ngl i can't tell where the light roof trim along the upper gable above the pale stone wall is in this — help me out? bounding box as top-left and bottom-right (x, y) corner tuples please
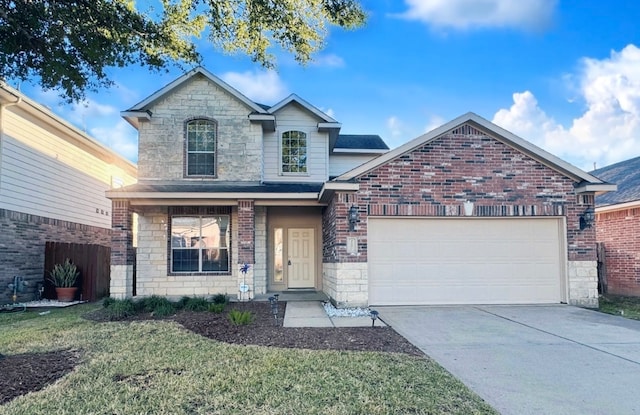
(120, 66), (268, 128)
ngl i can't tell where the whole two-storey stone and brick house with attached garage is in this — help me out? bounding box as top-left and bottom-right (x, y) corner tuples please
(108, 68), (615, 307)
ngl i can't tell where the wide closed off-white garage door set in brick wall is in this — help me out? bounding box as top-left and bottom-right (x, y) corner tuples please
(368, 218), (566, 305)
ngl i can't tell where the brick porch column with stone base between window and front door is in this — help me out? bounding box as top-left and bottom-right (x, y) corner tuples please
(238, 200), (256, 301)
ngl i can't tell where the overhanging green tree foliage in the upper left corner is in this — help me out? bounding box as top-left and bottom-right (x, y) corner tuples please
(0, 0), (365, 100)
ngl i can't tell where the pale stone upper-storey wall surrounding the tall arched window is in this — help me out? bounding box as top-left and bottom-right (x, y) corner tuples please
(138, 75), (262, 182)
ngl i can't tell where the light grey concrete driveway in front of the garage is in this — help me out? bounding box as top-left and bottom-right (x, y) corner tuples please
(375, 305), (640, 415)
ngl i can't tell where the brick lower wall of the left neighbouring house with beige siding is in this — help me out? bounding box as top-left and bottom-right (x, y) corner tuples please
(0, 209), (111, 304)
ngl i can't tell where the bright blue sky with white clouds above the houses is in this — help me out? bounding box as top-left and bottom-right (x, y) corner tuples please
(13, 0), (640, 171)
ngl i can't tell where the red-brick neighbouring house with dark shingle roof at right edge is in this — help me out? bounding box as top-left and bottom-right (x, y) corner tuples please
(591, 157), (640, 296)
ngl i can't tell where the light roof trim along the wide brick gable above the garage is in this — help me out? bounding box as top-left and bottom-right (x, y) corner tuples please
(334, 112), (615, 192)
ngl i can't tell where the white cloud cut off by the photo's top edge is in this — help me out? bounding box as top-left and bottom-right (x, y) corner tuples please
(402, 0), (558, 30)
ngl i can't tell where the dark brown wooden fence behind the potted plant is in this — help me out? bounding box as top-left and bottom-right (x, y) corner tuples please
(44, 242), (111, 301)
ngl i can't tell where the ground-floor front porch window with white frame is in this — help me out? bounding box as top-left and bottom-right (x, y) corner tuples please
(171, 215), (229, 273)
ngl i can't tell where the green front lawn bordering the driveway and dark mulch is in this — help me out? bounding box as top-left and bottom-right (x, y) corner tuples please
(0, 305), (496, 415)
